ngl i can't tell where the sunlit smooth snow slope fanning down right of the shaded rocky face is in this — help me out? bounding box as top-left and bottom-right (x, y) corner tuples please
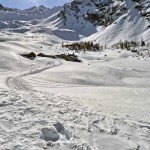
(88, 0), (150, 44)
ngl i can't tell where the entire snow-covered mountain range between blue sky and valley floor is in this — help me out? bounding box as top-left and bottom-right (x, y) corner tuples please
(0, 0), (150, 44)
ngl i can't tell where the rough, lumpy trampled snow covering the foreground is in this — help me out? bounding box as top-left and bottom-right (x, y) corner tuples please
(0, 89), (150, 150)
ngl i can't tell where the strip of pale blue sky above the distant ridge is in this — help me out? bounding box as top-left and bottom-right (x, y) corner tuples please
(0, 0), (70, 9)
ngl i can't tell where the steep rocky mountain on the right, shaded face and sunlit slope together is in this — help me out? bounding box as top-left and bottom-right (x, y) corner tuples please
(60, 0), (150, 43)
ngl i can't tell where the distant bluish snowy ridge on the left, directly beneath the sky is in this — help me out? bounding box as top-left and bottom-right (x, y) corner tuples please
(0, 6), (61, 33)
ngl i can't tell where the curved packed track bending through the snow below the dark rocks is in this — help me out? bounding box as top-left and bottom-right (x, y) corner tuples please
(5, 61), (62, 91)
